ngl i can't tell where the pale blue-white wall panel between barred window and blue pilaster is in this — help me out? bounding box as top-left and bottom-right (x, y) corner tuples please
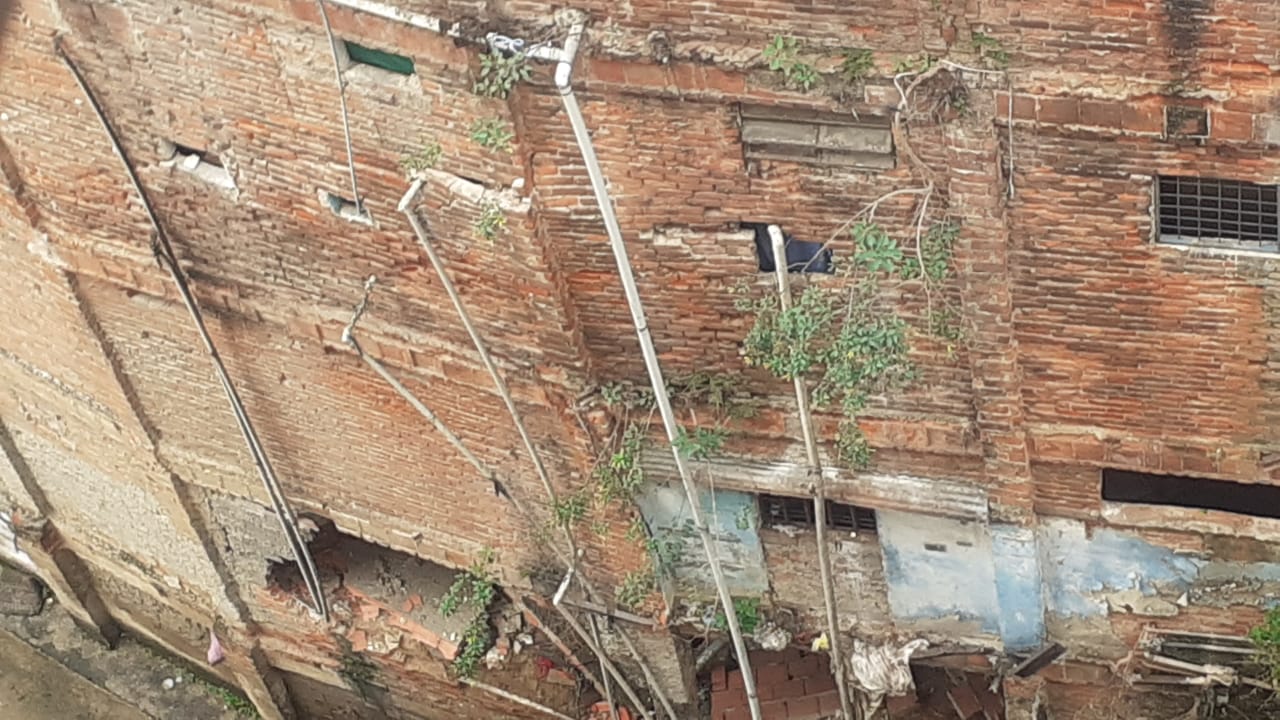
(877, 510), (1001, 637)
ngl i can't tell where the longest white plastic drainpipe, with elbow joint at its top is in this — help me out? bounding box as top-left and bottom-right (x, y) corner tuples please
(556, 23), (760, 720)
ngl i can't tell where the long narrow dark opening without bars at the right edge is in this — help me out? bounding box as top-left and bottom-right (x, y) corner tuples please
(1102, 469), (1280, 518)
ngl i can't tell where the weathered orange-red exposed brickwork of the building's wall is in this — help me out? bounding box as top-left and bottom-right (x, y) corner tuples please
(0, 0), (1280, 720)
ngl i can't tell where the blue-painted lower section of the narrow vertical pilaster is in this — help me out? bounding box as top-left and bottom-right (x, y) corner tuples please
(991, 525), (1044, 650)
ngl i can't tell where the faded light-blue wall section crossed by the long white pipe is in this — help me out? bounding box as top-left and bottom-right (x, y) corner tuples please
(636, 484), (769, 597)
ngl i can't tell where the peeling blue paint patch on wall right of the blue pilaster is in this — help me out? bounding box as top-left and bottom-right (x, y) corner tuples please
(1039, 519), (1203, 616)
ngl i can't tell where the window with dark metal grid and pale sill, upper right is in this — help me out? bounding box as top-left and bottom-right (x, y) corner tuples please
(1156, 176), (1280, 251)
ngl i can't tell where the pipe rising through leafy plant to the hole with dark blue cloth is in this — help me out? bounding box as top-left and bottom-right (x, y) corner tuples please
(769, 225), (854, 720)
